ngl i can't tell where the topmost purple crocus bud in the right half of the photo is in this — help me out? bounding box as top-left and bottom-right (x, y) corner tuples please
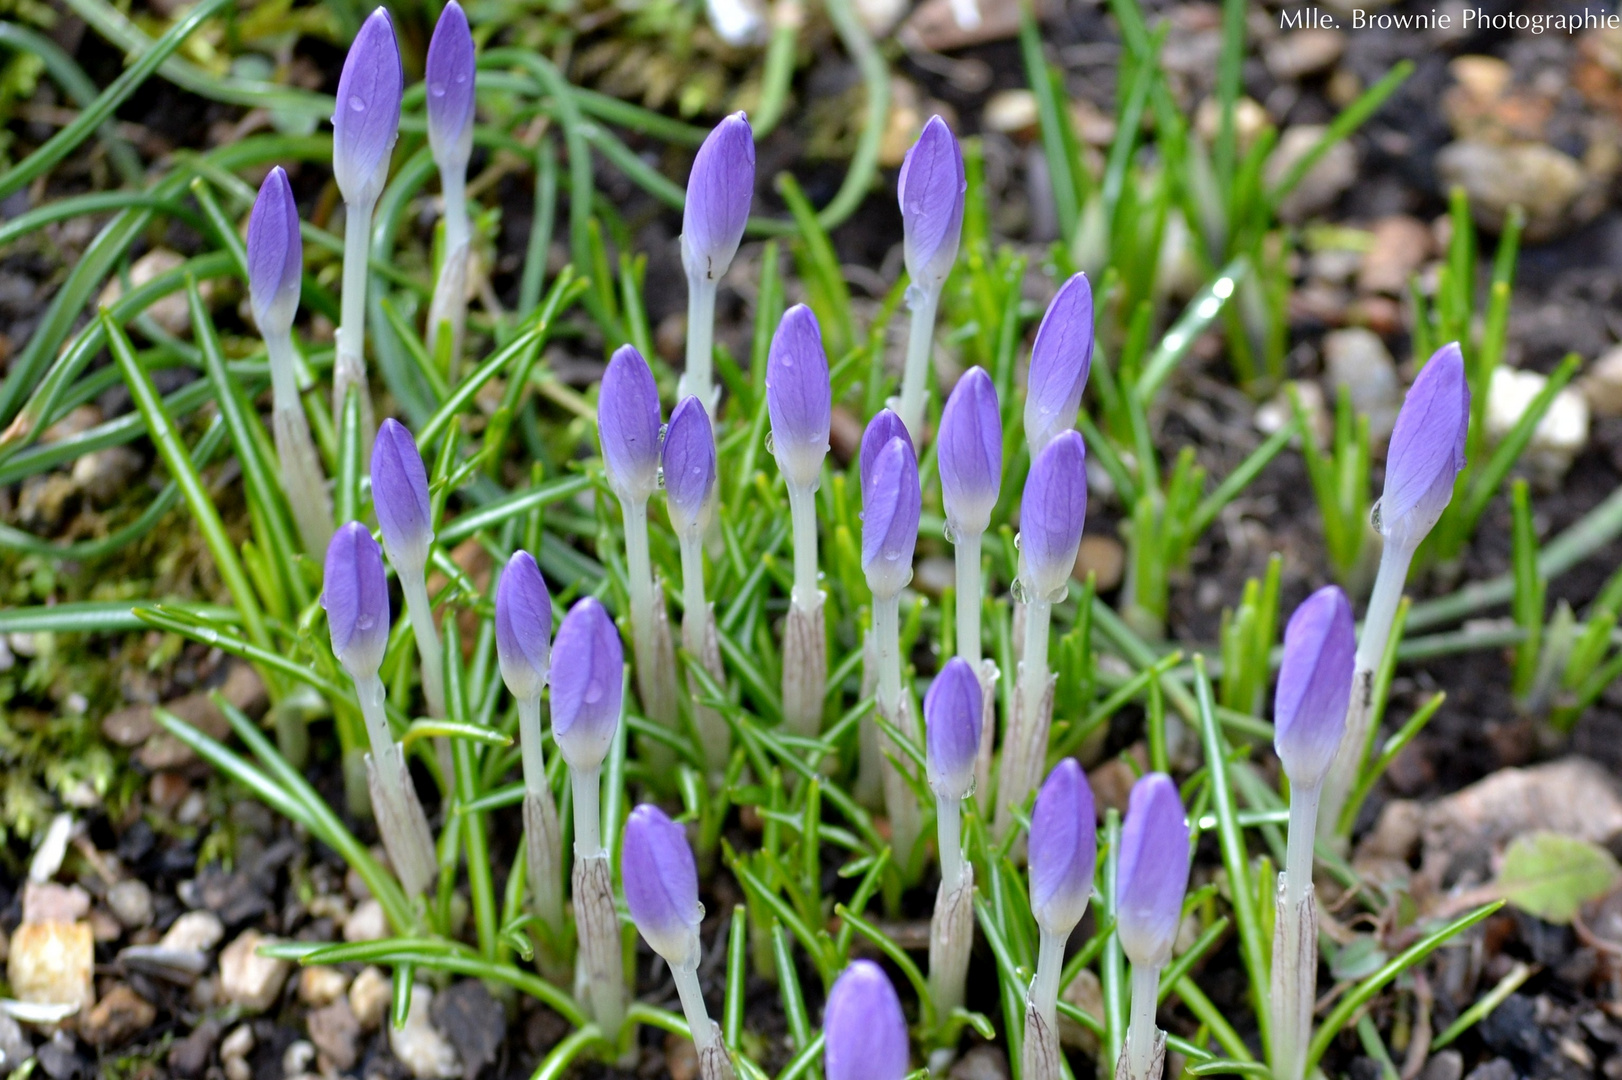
(895, 117), (968, 292)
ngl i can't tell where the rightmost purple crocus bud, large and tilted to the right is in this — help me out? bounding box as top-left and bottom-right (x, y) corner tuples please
(1374, 342), (1470, 548)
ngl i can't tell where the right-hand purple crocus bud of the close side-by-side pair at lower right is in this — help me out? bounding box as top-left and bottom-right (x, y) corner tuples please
(1116, 772), (1189, 968)
